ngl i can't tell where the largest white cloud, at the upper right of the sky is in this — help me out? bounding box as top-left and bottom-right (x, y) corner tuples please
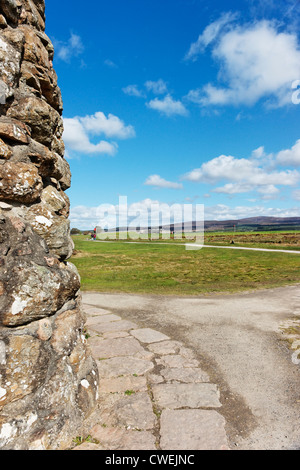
(187, 17), (300, 106)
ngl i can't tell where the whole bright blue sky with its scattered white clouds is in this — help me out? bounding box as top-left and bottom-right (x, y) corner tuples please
(46, 0), (300, 229)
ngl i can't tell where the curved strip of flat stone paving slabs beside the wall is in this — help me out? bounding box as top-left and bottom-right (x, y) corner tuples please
(75, 301), (229, 450)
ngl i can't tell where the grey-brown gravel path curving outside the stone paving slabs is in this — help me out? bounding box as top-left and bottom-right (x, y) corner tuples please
(83, 286), (300, 450)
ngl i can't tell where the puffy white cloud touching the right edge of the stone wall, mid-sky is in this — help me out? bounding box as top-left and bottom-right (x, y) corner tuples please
(63, 112), (135, 158)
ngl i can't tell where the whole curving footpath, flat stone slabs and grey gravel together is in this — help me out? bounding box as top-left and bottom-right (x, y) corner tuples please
(74, 286), (300, 450)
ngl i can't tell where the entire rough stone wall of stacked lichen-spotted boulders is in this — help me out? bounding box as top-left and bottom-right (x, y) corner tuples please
(0, 0), (98, 450)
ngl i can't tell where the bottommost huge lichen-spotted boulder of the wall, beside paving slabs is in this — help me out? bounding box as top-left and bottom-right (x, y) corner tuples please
(0, 302), (98, 450)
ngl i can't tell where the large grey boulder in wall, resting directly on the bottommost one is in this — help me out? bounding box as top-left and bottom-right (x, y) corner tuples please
(0, 217), (80, 326)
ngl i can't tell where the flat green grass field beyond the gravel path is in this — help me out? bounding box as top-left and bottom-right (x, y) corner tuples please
(70, 235), (300, 296)
